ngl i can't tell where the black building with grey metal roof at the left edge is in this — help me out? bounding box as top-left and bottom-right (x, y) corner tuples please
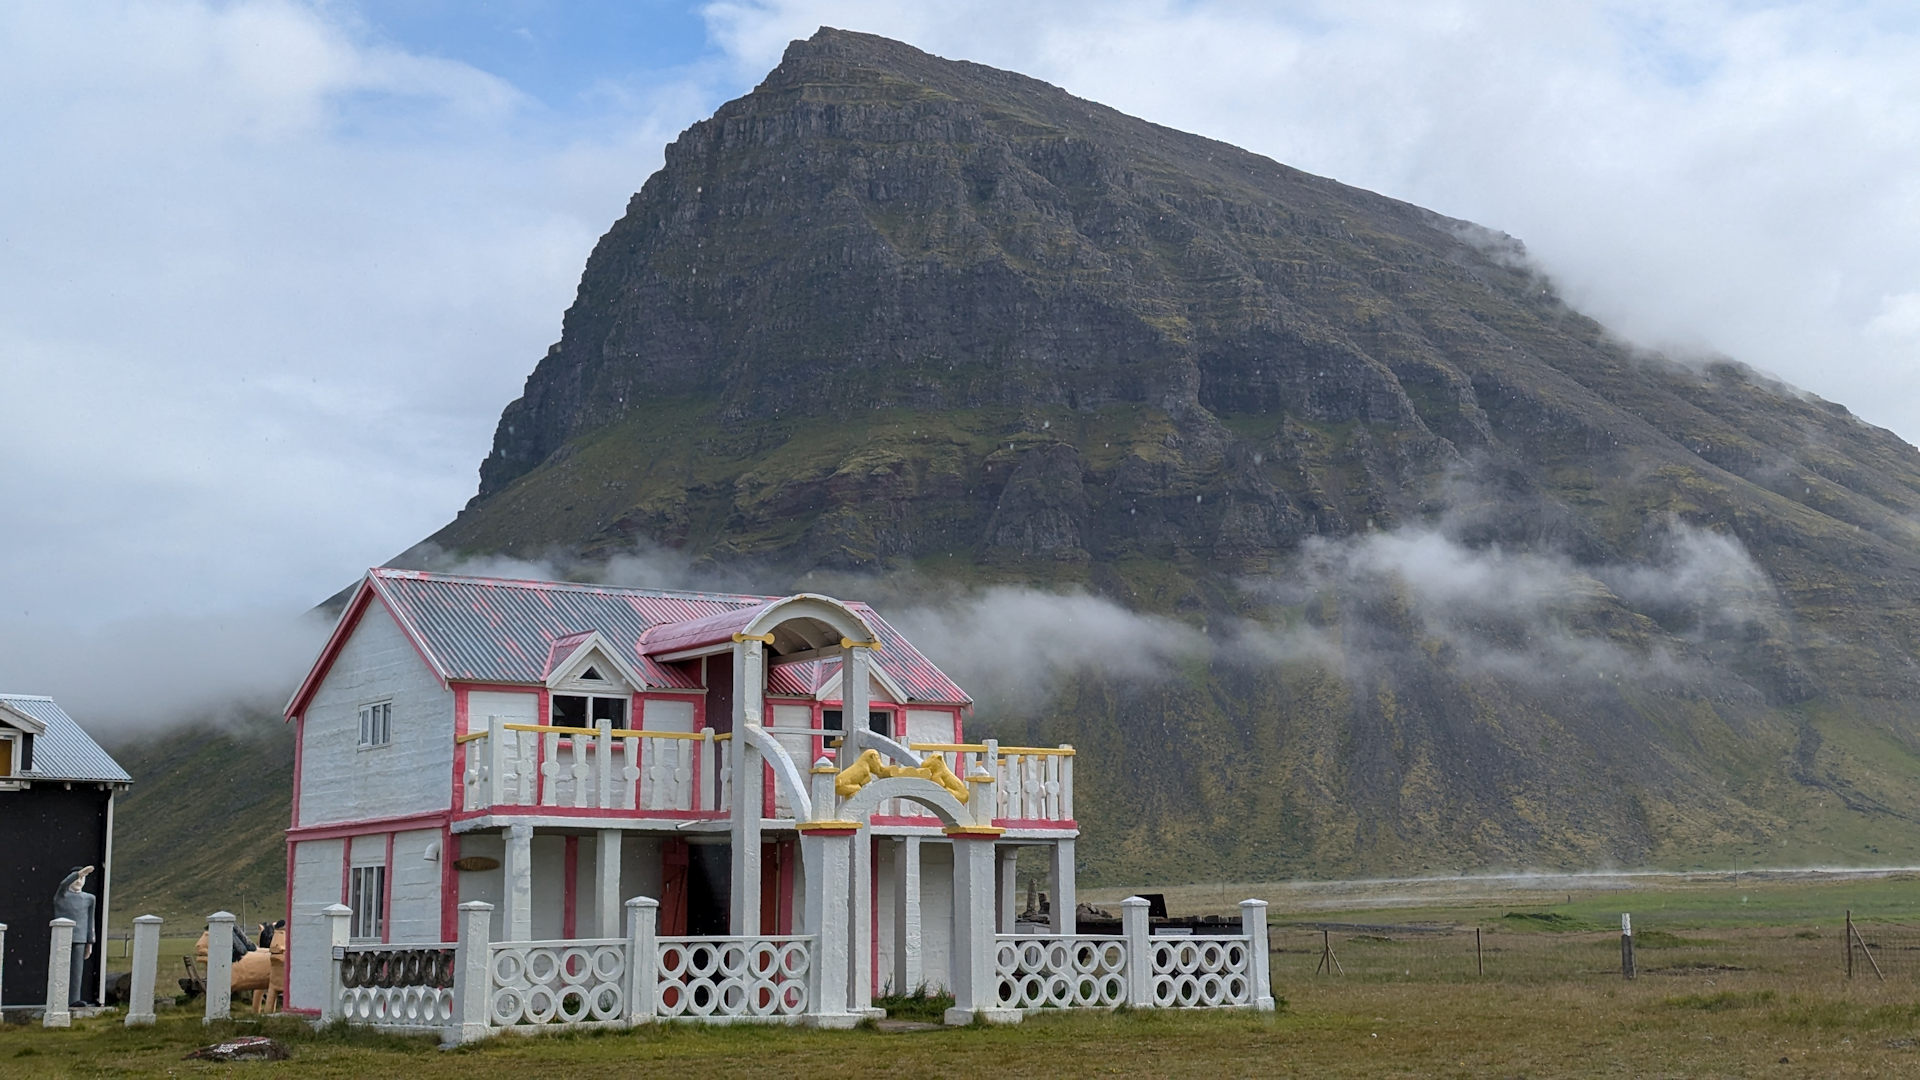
(0, 694), (132, 1007)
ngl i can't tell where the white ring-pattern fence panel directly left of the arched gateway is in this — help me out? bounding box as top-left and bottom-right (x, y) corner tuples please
(655, 936), (812, 1020)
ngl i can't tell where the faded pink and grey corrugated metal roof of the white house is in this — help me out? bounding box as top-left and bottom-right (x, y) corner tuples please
(369, 567), (972, 705)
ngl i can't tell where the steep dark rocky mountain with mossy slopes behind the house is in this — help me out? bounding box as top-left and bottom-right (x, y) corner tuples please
(434, 31), (1920, 876)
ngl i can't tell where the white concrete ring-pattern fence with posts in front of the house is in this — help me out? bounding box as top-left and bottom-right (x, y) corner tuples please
(316, 887), (1273, 1043)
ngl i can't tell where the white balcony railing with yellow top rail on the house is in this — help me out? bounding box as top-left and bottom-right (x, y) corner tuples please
(457, 717), (1075, 830)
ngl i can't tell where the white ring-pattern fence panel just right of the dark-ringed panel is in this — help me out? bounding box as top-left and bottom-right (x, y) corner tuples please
(488, 938), (628, 1028)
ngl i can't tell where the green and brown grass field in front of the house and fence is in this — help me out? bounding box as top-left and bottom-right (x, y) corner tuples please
(11, 874), (1920, 1080)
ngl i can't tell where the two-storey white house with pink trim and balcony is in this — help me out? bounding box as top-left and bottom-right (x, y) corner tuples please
(286, 569), (1090, 1013)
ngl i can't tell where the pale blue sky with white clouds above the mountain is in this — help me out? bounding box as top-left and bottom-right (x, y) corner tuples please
(0, 0), (1920, 722)
